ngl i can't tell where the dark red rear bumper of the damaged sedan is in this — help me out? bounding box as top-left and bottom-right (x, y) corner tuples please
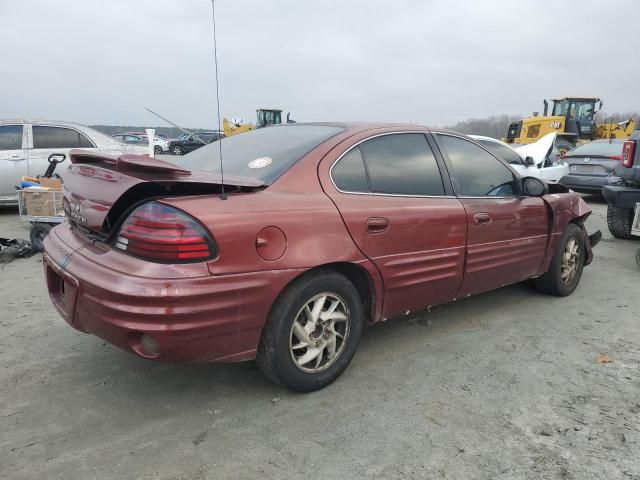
(44, 225), (301, 362)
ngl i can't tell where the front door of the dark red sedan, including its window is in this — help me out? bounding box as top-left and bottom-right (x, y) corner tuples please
(435, 133), (549, 296)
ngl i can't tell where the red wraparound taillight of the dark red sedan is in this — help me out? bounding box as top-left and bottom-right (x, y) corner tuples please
(115, 202), (216, 263)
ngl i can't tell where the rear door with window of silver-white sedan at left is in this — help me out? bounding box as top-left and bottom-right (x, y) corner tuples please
(29, 125), (96, 176)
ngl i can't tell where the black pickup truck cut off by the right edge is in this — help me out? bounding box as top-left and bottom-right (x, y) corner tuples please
(602, 129), (640, 238)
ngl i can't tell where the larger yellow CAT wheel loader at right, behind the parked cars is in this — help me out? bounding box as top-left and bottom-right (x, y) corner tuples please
(504, 97), (636, 153)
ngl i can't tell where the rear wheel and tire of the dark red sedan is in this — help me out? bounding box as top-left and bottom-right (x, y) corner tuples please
(256, 271), (364, 392)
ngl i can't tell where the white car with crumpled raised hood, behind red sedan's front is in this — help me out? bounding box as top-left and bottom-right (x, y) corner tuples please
(469, 132), (569, 182)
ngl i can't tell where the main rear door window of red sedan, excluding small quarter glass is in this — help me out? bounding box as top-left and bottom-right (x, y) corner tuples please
(360, 133), (444, 195)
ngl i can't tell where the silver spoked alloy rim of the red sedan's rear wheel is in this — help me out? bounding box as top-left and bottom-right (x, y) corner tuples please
(289, 293), (351, 373)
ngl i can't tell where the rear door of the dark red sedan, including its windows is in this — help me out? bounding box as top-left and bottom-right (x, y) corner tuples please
(321, 132), (466, 318)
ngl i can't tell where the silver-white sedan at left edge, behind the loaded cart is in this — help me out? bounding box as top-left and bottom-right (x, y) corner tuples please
(0, 119), (149, 205)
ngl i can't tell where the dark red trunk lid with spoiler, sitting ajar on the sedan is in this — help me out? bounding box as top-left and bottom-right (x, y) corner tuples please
(63, 150), (264, 233)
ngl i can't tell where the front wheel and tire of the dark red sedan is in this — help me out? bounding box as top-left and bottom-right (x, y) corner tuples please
(533, 223), (587, 297)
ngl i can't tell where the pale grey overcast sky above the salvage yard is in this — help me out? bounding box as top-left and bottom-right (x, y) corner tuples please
(0, 0), (640, 128)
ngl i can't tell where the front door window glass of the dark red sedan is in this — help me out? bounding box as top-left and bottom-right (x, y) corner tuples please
(437, 134), (517, 197)
